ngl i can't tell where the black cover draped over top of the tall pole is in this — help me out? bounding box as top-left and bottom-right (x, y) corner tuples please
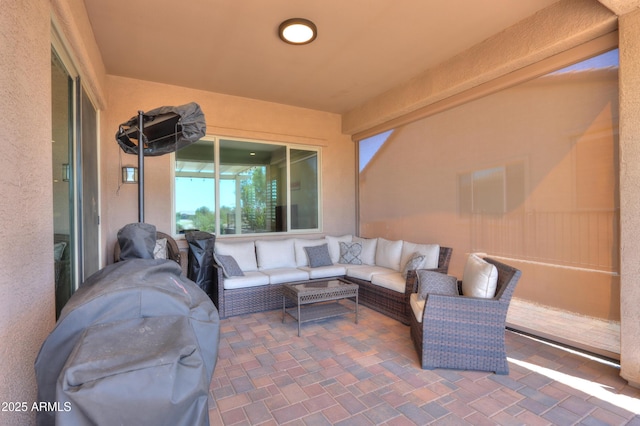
(116, 102), (207, 157)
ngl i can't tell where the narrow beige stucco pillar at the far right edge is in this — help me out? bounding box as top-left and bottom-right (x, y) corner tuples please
(620, 6), (640, 387)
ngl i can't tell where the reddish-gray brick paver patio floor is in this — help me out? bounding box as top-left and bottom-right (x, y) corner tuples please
(209, 302), (640, 426)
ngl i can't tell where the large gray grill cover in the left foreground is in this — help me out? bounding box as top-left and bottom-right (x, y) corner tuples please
(35, 259), (220, 426)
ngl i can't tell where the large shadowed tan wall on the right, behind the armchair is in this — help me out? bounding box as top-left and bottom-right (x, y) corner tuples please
(360, 69), (620, 320)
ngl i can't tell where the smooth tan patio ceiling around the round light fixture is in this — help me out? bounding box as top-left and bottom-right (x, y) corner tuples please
(84, 0), (558, 113)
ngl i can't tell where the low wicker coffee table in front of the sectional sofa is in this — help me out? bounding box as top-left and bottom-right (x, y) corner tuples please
(282, 278), (358, 336)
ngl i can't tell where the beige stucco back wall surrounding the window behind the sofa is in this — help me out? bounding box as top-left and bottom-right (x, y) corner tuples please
(101, 76), (356, 263)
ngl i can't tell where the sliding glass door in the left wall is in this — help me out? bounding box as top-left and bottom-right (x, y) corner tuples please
(51, 49), (100, 315)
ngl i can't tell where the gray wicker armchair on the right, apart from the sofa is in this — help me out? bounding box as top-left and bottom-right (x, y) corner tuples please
(407, 258), (521, 374)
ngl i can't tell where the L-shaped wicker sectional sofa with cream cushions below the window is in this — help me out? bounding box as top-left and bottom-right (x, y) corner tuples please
(210, 235), (452, 324)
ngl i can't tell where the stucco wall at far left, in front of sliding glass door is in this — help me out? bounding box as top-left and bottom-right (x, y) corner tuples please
(0, 0), (55, 425)
